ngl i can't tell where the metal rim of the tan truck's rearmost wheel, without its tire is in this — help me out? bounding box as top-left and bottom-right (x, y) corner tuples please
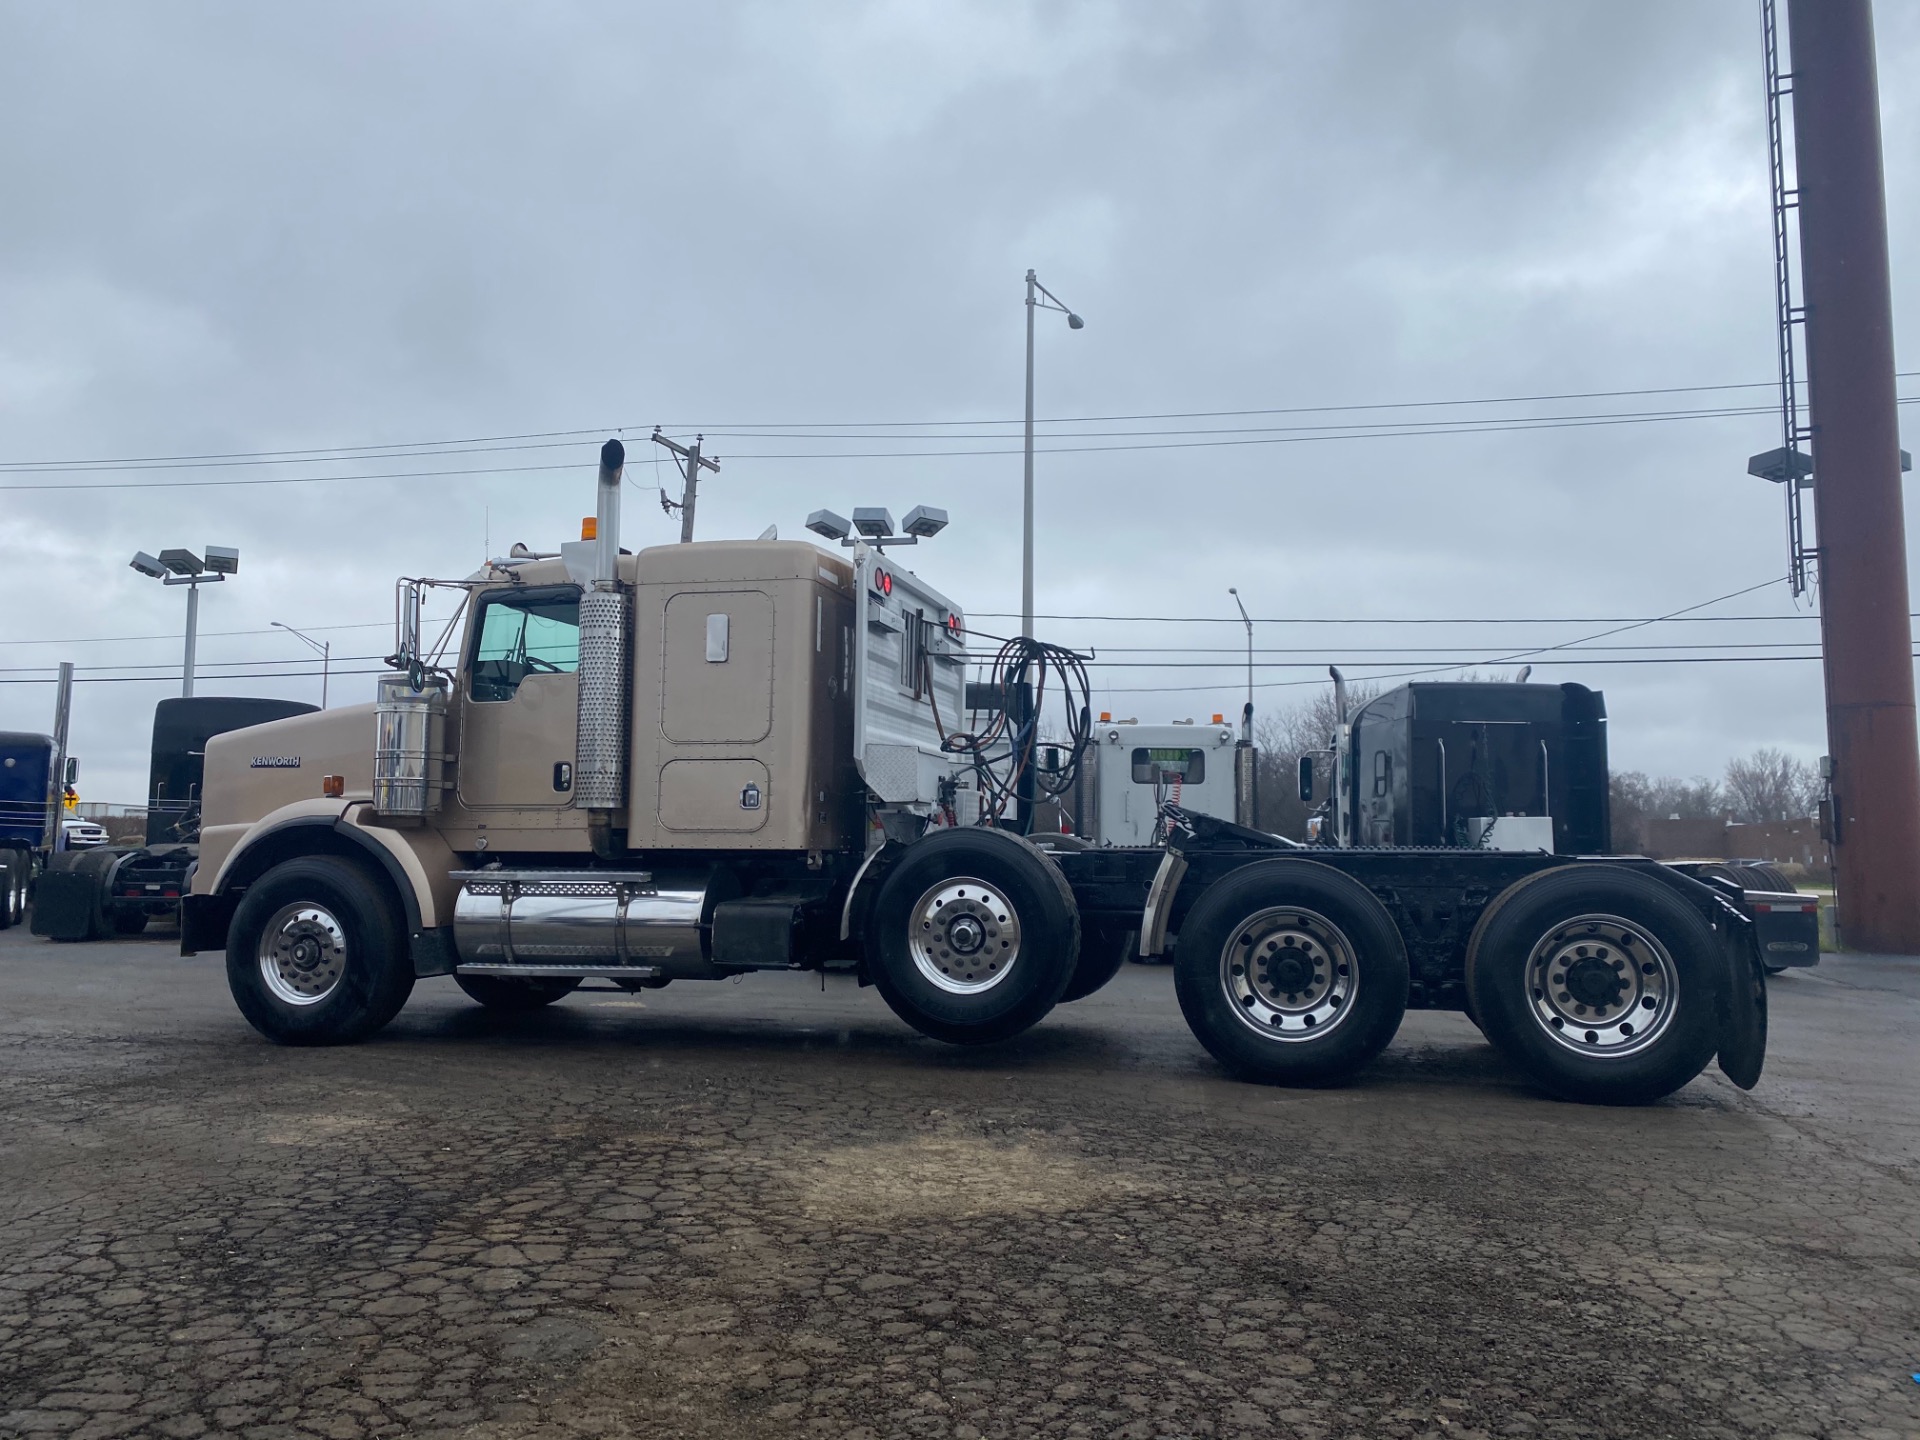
(1526, 914), (1680, 1058)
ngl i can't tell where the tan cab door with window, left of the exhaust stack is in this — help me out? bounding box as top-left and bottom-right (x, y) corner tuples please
(457, 586), (580, 810)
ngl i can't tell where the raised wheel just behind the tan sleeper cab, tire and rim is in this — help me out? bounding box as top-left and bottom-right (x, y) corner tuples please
(866, 828), (1081, 1044)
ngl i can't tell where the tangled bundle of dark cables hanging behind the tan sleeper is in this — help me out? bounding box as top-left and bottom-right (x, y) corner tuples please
(927, 637), (1092, 824)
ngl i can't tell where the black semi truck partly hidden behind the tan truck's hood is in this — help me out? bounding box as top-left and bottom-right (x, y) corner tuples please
(33, 695), (317, 941)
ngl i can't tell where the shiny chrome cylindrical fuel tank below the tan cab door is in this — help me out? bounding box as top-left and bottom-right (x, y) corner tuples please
(453, 870), (722, 979)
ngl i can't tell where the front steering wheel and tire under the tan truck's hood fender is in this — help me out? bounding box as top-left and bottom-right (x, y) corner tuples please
(227, 854), (413, 1044)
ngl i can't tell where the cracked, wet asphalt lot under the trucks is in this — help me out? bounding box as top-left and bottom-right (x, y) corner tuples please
(0, 929), (1920, 1438)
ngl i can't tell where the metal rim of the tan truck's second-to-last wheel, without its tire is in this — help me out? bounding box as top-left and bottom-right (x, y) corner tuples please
(1219, 904), (1359, 1044)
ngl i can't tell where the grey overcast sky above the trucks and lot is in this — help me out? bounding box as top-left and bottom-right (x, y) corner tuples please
(0, 0), (1920, 801)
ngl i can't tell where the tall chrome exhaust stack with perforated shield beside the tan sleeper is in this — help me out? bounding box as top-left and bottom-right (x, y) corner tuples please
(574, 440), (630, 840)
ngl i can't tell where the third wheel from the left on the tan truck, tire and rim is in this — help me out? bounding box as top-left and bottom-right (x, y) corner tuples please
(1173, 858), (1407, 1085)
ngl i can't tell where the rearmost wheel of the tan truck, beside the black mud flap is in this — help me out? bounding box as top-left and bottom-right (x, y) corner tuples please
(1467, 864), (1722, 1104)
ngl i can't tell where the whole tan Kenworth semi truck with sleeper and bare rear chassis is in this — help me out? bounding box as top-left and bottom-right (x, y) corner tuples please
(182, 442), (1766, 1102)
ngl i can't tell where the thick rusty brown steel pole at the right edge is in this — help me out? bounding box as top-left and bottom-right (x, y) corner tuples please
(1788, 0), (1920, 954)
